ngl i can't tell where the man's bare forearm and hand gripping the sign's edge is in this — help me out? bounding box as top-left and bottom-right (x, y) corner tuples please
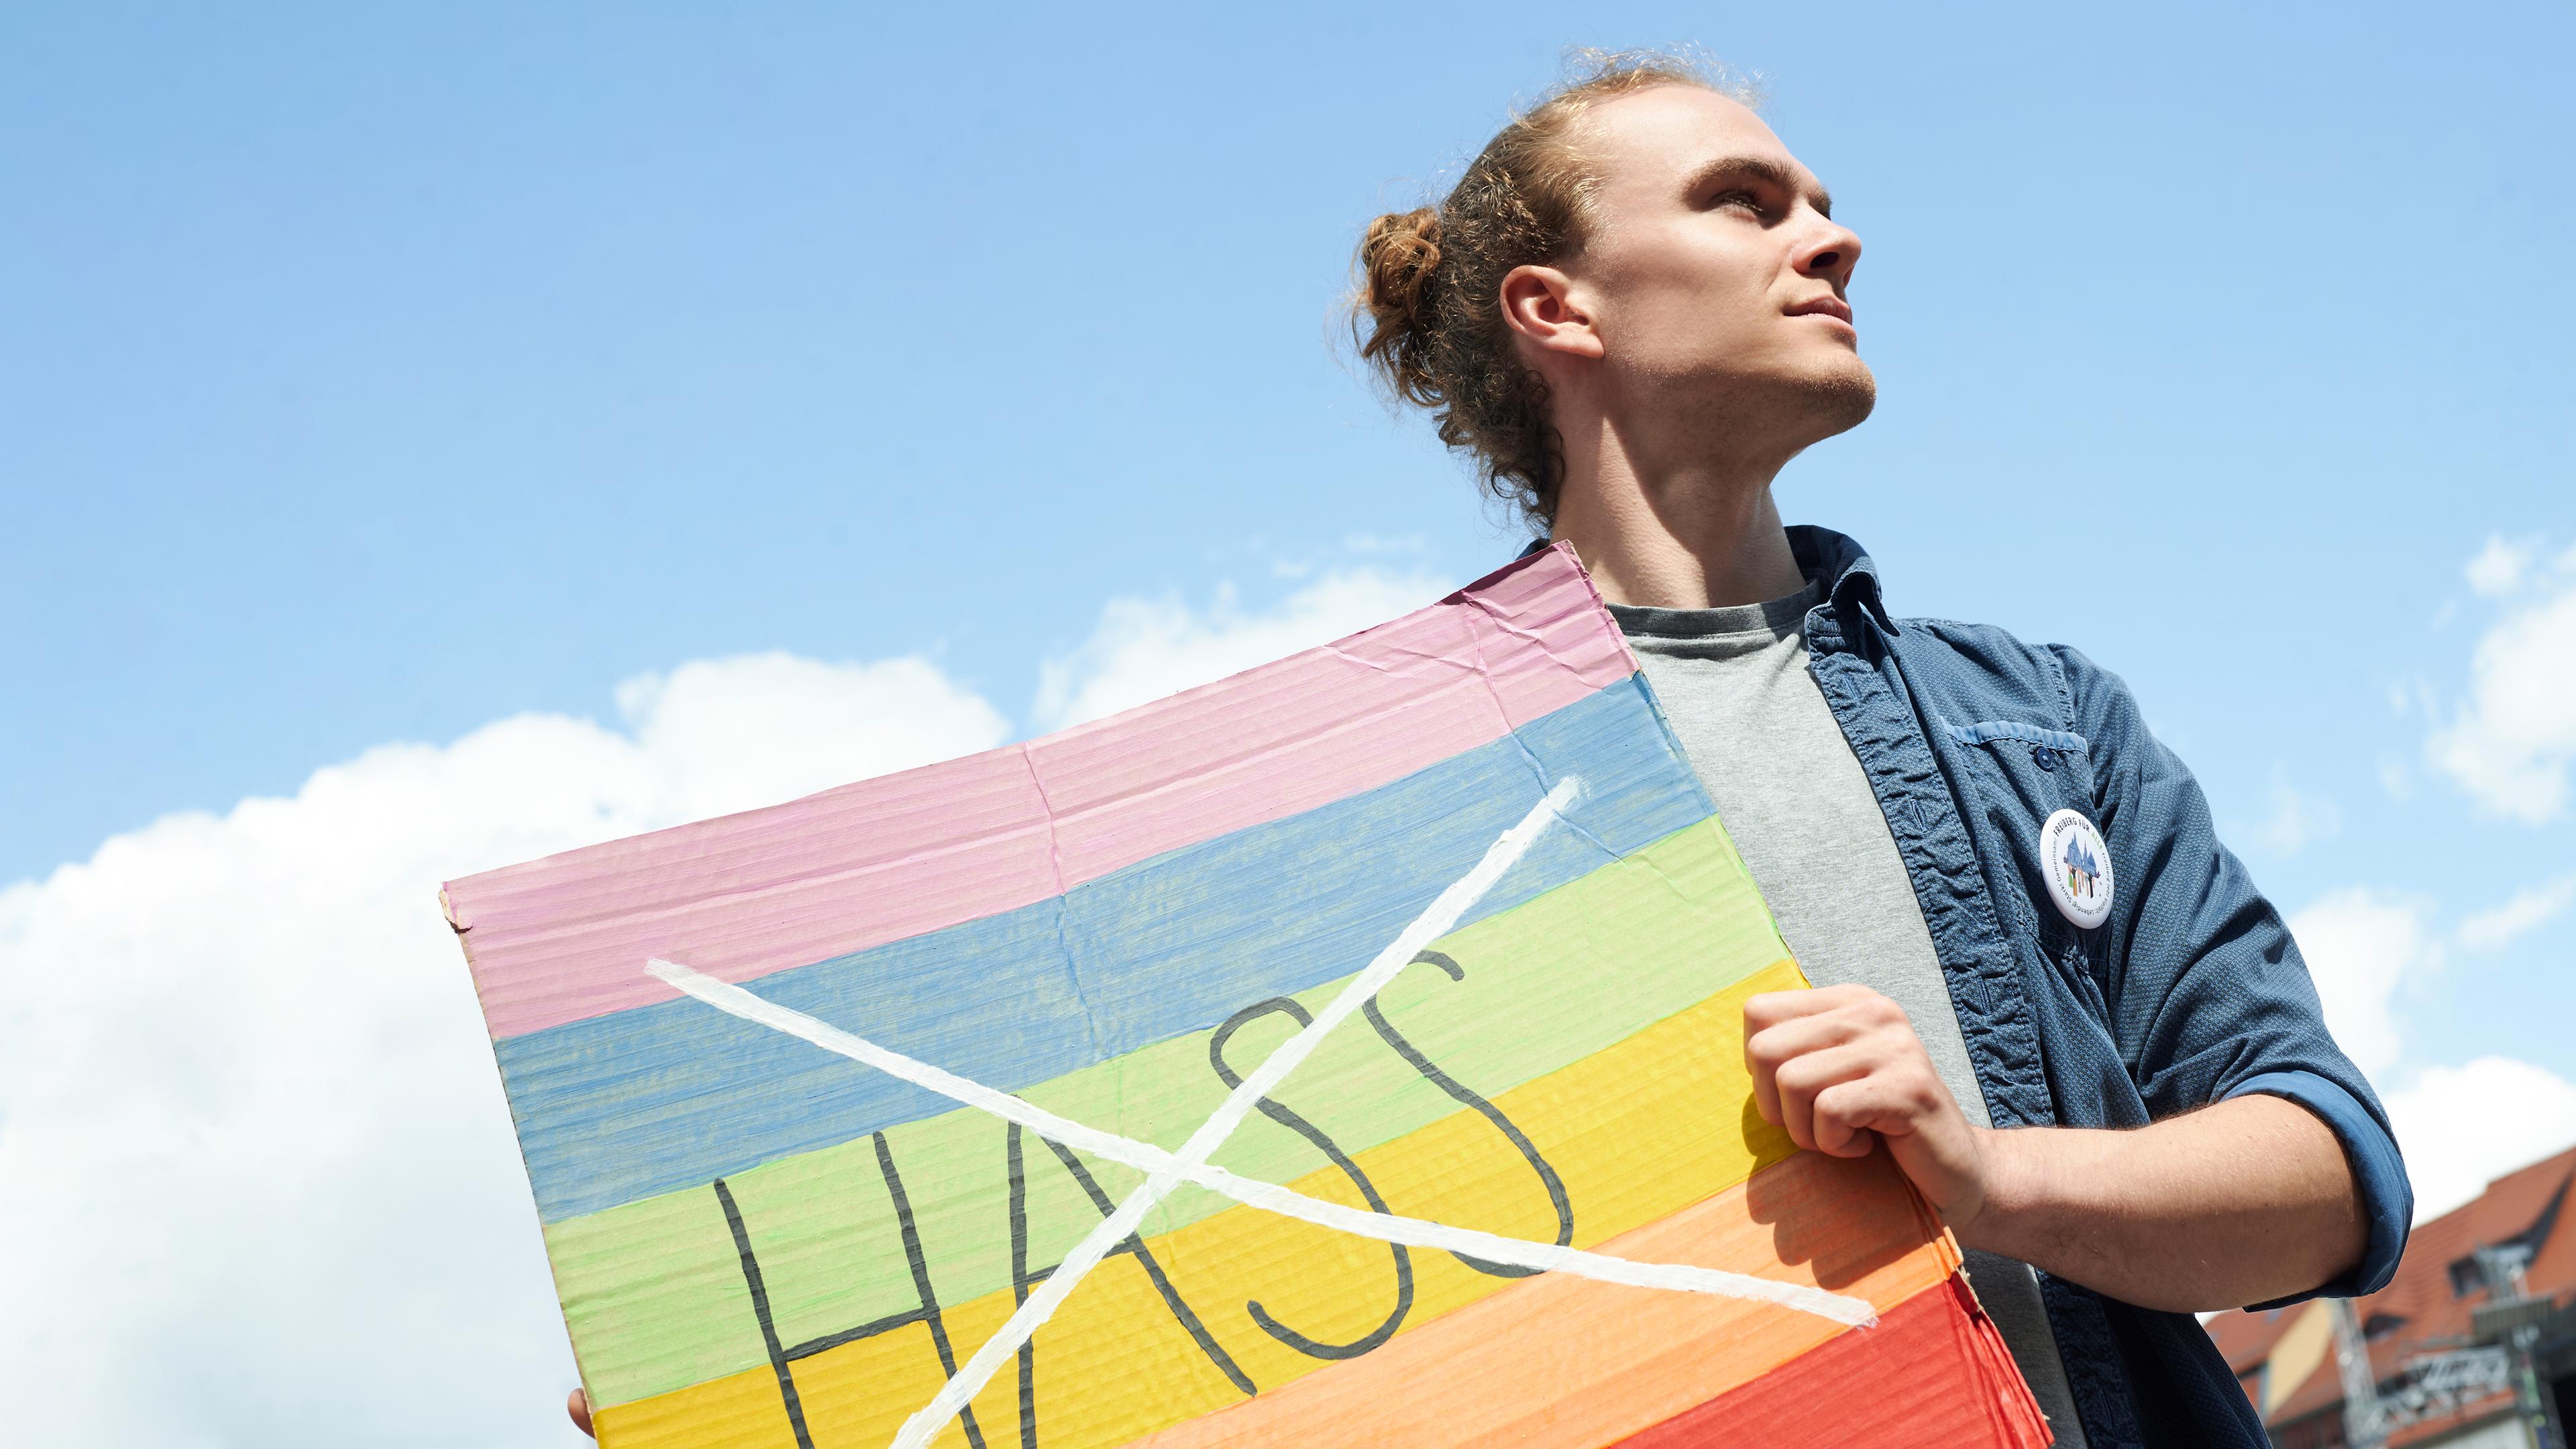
(1744, 985), (2367, 1312)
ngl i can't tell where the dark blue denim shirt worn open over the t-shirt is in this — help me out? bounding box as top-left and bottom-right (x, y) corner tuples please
(1525, 529), (2414, 1449)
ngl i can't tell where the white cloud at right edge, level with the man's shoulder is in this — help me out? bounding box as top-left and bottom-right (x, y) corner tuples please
(2424, 567), (2576, 825)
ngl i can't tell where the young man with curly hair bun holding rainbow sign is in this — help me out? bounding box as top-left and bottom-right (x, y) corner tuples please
(1360, 59), (2411, 1449)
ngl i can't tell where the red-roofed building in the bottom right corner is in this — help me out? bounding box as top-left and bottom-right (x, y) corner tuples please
(2208, 1147), (2576, 1449)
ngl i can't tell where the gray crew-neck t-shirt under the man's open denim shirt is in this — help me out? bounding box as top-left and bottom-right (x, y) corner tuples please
(1610, 583), (2084, 1449)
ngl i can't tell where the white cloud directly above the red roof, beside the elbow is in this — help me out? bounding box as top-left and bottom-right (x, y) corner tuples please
(2385, 1057), (2576, 1222)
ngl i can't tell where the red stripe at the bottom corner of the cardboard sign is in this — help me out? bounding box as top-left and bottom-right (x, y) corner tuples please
(1618, 1279), (2053, 1449)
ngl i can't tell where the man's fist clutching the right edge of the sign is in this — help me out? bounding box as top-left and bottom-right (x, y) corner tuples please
(1744, 985), (1986, 1232)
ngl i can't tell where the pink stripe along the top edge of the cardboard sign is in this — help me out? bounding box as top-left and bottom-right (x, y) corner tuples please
(445, 544), (1635, 1036)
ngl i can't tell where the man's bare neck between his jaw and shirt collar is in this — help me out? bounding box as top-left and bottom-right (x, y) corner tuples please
(1554, 415), (1806, 608)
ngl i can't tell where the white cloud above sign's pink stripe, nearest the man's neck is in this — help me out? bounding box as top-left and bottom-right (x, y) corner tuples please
(1036, 570), (1453, 730)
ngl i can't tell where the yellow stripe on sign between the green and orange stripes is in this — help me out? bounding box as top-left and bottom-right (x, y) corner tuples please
(600, 962), (1806, 1449)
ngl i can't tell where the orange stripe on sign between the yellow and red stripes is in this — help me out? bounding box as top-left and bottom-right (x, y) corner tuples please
(1134, 1152), (1957, 1449)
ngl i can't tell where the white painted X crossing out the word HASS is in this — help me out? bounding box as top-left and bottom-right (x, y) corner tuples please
(647, 779), (1878, 1449)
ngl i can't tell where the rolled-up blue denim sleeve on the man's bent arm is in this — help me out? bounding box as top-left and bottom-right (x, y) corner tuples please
(2053, 647), (2414, 1307)
